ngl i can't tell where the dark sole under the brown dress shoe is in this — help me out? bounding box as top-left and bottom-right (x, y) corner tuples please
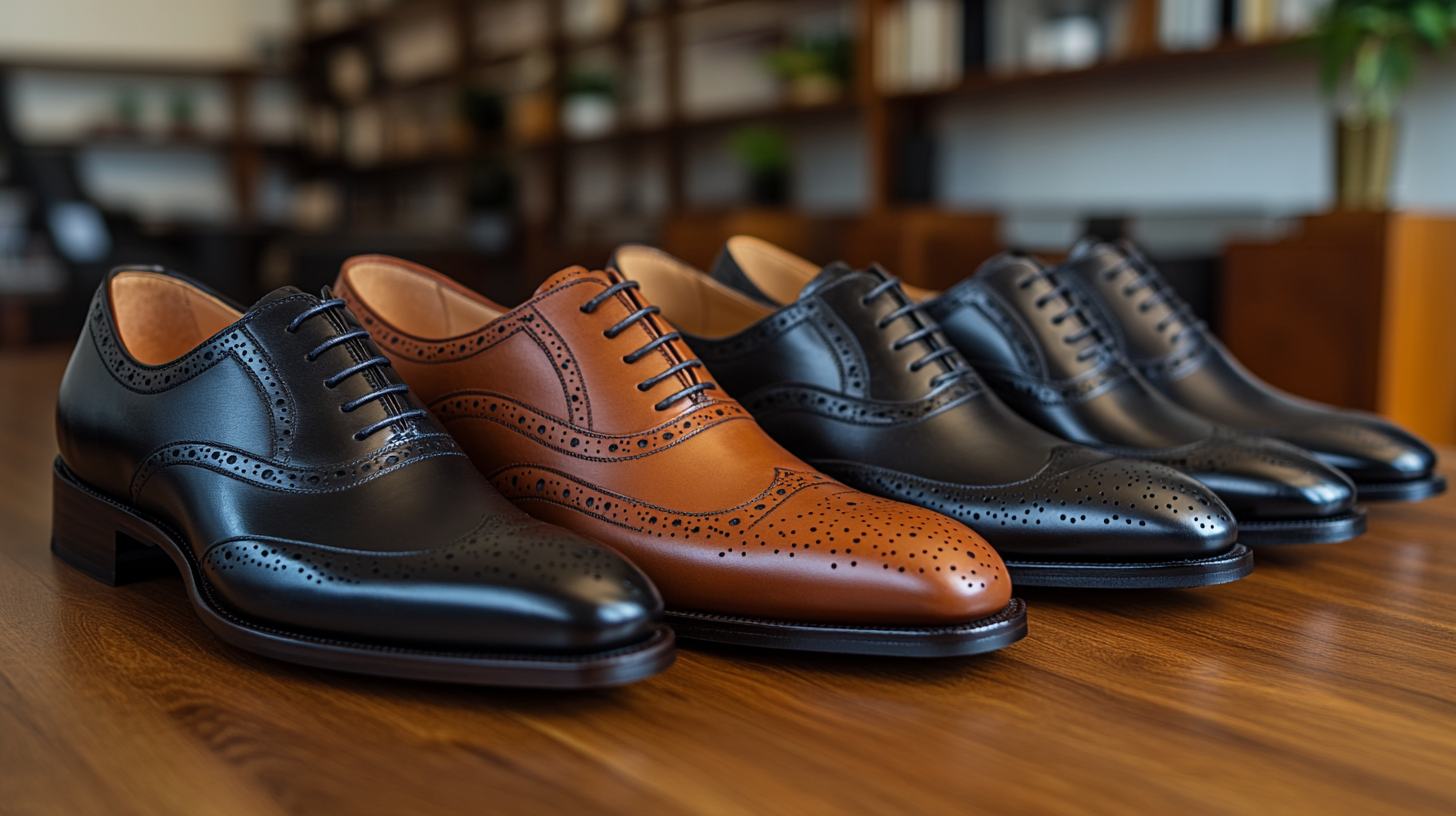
(667, 597), (1026, 657)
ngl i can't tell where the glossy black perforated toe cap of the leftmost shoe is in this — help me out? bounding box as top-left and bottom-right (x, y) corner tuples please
(202, 514), (662, 650)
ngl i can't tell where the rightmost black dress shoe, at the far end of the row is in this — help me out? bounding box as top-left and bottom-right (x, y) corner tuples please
(1061, 240), (1446, 501)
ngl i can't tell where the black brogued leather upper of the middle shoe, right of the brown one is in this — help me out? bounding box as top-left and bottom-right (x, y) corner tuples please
(614, 241), (1236, 560)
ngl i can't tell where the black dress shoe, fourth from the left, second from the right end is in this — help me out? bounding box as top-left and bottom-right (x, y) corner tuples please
(925, 255), (1366, 544)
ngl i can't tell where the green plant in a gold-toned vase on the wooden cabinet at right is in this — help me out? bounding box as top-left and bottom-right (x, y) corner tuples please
(1312, 0), (1456, 210)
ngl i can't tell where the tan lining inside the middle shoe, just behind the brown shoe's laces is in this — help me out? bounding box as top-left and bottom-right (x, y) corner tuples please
(616, 246), (775, 338)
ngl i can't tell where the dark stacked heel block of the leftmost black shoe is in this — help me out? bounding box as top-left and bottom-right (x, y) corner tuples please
(51, 458), (176, 586)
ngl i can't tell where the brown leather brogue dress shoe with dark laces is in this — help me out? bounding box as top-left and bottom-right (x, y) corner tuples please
(336, 255), (1026, 656)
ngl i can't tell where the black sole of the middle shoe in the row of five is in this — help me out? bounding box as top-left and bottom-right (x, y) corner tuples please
(1002, 544), (1254, 589)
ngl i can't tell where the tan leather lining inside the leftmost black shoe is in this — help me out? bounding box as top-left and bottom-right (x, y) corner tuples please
(111, 271), (243, 366)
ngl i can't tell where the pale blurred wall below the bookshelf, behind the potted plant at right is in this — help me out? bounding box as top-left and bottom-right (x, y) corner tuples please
(936, 57), (1456, 246)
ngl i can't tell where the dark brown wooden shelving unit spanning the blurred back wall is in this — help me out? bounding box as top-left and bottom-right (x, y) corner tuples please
(300, 0), (1310, 275)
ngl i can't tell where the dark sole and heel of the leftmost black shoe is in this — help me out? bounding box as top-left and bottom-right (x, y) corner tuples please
(51, 458), (677, 689)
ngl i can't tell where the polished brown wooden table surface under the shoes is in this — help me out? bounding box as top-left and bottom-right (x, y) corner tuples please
(0, 351), (1456, 816)
